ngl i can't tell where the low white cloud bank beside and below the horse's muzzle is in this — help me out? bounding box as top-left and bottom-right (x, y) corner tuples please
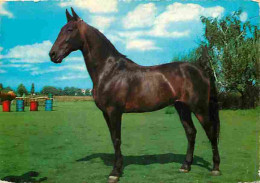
(0, 40), (86, 75)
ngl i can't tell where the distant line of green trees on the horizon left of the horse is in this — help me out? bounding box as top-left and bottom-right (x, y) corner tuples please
(0, 83), (92, 96)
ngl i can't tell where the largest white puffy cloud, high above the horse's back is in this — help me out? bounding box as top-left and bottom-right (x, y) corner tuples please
(119, 3), (224, 39)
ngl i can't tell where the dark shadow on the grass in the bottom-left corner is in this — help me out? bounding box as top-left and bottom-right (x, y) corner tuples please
(1, 171), (47, 183)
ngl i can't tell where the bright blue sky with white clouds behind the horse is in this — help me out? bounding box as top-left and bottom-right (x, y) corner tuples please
(0, 0), (259, 91)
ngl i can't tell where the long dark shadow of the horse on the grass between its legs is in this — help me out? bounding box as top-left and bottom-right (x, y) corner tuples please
(76, 153), (211, 170)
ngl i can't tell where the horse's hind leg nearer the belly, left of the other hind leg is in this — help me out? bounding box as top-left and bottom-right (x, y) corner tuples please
(174, 102), (197, 173)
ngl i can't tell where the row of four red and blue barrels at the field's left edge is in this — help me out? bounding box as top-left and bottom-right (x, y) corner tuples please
(2, 100), (53, 112)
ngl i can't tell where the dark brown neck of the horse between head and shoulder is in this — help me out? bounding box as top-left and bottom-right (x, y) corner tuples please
(81, 27), (120, 87)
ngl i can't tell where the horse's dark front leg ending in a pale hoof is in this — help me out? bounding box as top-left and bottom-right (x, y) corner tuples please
(103, 109), (123, 183)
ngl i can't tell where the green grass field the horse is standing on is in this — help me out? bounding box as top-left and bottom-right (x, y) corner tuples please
(0, 101), (259, 183)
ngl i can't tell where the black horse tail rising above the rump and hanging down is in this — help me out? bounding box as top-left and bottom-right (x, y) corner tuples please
(198, 46), (220, 142)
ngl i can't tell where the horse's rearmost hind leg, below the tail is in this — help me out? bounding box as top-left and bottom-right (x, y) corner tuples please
(195, 110), (220, 175)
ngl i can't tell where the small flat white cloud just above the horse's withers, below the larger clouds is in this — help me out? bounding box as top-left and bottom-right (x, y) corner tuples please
(126, 39), (160, 51)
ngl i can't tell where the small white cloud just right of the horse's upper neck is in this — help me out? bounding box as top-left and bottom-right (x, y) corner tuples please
(91, 16), (116, 30)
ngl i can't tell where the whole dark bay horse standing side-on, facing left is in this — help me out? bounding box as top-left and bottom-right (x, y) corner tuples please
(49, 8), (220, 183)
